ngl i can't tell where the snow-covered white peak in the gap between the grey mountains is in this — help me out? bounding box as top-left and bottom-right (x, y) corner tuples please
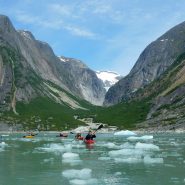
(96, 71), (122, 91)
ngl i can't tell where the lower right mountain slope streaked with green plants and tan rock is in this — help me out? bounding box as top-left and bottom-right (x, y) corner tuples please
(132, 52), (185, 130)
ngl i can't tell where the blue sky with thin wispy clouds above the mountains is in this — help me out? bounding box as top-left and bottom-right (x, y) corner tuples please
(0, 0), (185, 76)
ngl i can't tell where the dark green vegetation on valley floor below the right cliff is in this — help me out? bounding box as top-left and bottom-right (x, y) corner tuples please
(95, 100), (150, 129)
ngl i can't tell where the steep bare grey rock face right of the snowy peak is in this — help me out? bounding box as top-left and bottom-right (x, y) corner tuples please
(104, 22), (185, 105)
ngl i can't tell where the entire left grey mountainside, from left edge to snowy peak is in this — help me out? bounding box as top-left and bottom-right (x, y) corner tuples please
(0, 15), (105, 113)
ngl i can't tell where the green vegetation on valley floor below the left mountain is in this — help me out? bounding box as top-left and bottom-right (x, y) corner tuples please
(4, 97), (83, 130)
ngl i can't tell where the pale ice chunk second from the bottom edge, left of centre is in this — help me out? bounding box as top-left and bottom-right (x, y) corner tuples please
(62, 168), (92, 180)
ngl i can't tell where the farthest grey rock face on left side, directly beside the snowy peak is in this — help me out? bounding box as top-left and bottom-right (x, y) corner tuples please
(59, 57), (106, 105)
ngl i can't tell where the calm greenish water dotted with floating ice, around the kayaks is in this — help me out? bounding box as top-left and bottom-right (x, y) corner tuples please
(0, 133), (185, 185)
